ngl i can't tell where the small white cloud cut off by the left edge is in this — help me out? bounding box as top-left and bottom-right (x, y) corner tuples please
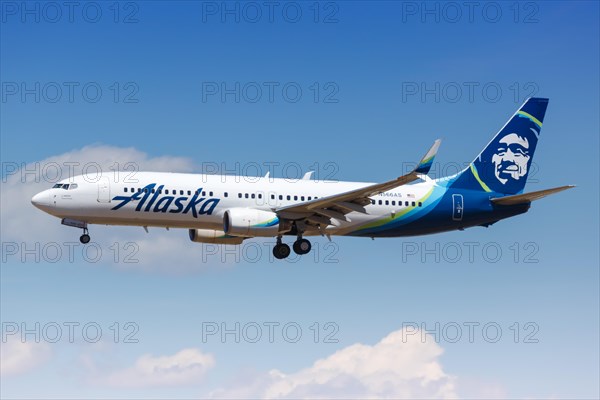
(0, 336), (51, 378)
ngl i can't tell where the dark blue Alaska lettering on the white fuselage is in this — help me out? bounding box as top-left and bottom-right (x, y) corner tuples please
(111, 183), (220, 218)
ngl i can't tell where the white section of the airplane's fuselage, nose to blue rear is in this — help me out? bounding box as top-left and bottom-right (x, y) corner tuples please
(32, 172), (434, 235)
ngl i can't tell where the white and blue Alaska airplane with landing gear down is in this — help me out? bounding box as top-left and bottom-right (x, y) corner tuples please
(31, 98), (574, 259)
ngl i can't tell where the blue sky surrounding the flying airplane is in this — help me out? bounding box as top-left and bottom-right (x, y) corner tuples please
(0, 1), (600, 398)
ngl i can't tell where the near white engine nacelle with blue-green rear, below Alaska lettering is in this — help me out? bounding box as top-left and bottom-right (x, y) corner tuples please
(223, 208), (279, 237)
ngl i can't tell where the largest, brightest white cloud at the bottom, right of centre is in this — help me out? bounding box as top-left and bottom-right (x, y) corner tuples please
(211, 330), (457, 399)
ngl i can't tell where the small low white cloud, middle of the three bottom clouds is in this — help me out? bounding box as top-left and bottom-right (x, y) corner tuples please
(99, 348), (215, 387)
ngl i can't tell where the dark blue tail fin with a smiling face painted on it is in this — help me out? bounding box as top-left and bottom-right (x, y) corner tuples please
(452, 97), (548, 194)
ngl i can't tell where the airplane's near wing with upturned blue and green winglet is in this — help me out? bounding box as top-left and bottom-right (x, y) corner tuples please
(275, 139), (441, 226)
